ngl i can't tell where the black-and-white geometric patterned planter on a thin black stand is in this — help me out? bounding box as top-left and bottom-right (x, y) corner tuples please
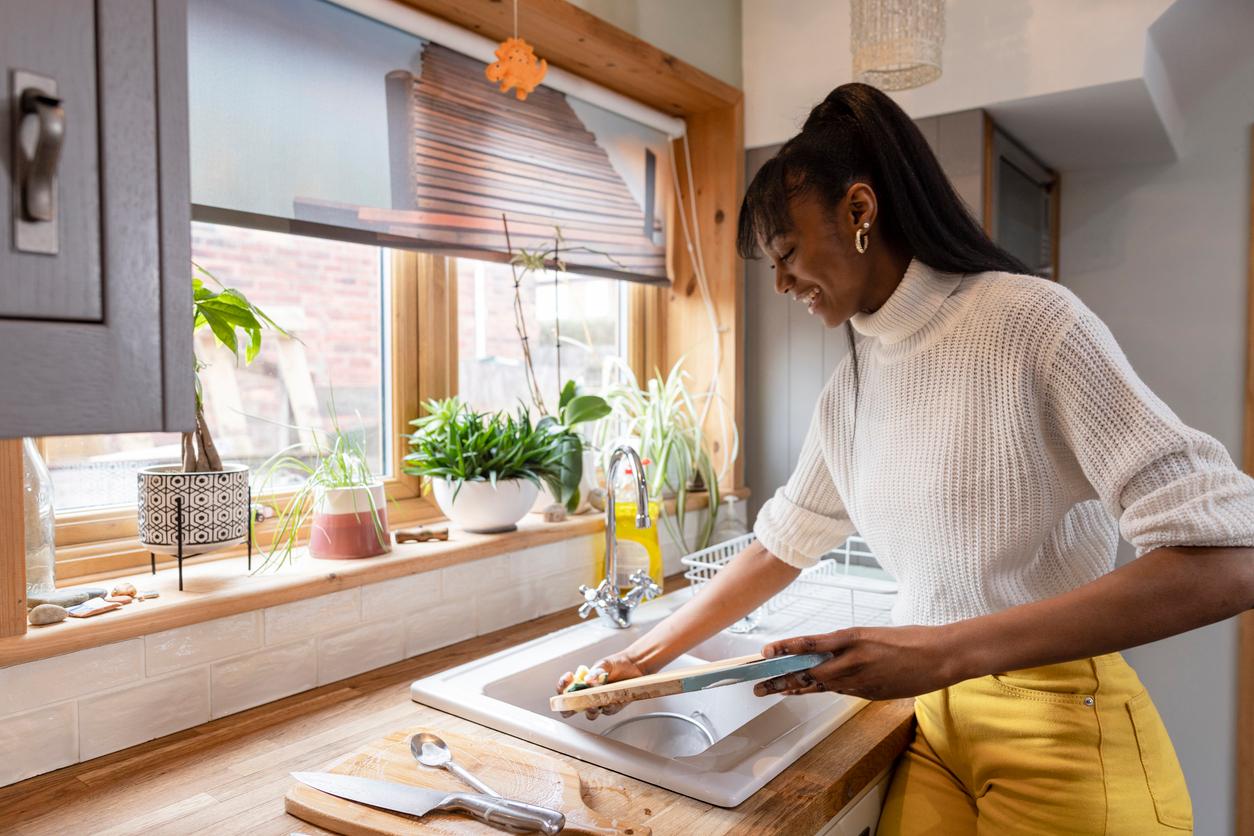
(139, 464), (248, 556)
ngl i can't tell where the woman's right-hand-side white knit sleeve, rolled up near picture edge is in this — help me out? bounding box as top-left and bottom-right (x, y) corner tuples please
(1047, 302), (1254, 556)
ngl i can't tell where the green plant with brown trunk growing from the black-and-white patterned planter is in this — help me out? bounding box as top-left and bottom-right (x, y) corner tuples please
(183, 262), (291, 473)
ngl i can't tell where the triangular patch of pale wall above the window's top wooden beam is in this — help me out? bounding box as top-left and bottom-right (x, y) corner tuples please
(571, 0), (741, 86)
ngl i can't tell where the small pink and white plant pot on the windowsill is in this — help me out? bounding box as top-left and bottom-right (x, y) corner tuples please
(310, 483), (391, 560)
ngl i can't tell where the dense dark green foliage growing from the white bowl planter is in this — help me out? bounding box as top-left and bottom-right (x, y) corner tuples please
(404, 397), (578, 498)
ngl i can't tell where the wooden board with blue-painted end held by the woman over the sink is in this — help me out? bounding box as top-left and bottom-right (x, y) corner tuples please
(549, 653), (831, 711)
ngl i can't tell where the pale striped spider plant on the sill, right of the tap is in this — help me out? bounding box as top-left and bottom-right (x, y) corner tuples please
(602, 357), (740, 551)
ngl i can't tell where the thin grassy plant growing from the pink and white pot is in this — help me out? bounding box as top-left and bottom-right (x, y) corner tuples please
(245, 395), (378, 572)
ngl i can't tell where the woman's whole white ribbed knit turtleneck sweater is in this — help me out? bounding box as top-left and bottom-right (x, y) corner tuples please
(755, 261), (1254, 624)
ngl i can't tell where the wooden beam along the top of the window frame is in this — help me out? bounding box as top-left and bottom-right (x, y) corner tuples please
(396, 0), (741, 117)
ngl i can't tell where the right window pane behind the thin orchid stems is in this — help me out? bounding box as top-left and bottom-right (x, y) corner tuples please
(456, 258), (628, 411)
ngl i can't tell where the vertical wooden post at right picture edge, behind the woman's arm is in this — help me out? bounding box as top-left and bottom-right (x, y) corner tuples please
(1236, 125), (1254, 833)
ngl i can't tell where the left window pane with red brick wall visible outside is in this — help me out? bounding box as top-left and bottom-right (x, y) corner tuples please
(43, 223), (391, 511)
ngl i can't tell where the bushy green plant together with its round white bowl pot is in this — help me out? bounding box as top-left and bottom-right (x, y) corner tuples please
(404, 397), (569, 533)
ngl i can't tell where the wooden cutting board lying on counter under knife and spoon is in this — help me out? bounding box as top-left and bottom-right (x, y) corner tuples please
(283, 727), (651, 836)
